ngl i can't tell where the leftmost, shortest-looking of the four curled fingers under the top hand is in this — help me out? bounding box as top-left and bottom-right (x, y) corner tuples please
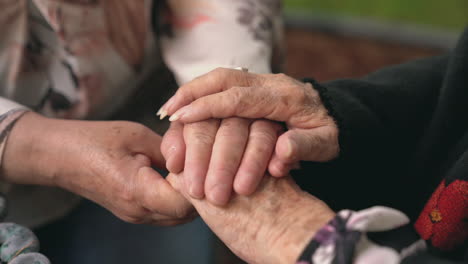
(161, 122), (185, 173)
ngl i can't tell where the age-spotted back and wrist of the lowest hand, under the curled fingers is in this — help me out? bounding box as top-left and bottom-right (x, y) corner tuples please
(167, 174), (335, 264)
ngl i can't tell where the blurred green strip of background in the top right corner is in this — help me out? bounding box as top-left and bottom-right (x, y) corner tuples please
(284, 0), (468, 31)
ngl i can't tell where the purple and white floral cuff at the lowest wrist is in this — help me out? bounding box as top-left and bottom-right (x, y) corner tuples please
(296, 206), (427, 264)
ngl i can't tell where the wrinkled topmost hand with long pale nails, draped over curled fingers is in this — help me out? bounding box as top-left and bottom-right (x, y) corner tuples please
(162, 68), (339, 177)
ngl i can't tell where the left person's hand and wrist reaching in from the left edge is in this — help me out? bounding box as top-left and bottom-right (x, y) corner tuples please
(2, 112), (195, 225)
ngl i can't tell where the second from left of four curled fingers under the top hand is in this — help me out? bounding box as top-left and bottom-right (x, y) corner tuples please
(184, 119), (219, 199)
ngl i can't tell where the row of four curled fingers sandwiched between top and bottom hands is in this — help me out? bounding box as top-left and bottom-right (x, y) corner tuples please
(161, 118), (282, 206)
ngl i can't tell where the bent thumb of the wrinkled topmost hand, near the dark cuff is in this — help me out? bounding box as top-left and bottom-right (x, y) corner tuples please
(275, 126), (338, 164)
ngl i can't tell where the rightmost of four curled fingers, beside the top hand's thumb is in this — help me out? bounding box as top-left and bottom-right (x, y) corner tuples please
(234, 120), (282, 195)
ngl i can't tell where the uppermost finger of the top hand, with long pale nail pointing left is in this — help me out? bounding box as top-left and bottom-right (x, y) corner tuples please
(163, 68), (262, 116)
